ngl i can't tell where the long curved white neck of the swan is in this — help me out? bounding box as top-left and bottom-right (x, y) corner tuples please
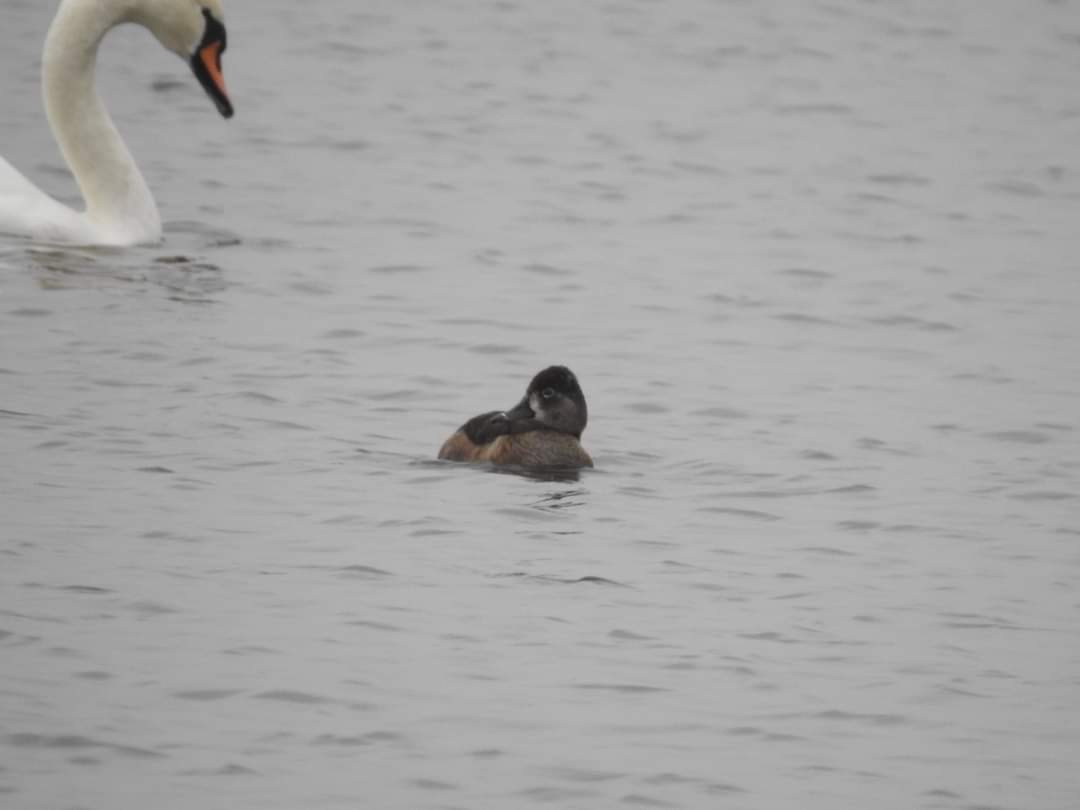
(42, 0), (161, 241)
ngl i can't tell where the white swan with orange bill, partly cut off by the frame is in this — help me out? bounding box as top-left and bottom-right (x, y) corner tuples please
(0, 0), (232, 245)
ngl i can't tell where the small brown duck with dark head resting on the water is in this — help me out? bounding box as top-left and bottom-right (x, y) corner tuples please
(438, 366), (593, 469)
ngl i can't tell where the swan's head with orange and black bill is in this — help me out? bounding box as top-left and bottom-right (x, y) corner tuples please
(135, 0), (232, 118)
